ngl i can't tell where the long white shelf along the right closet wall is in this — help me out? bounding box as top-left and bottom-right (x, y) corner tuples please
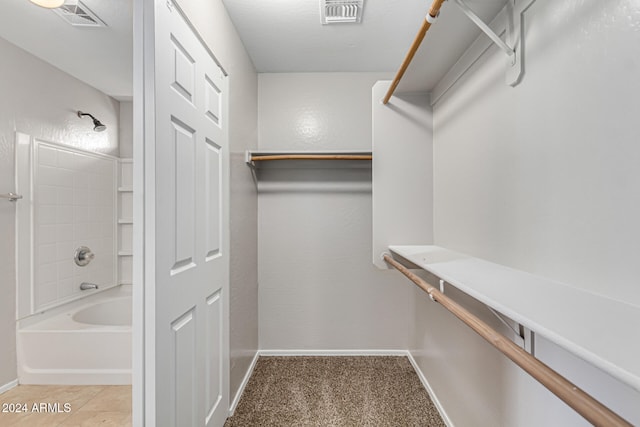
(389, 246), (640, 391)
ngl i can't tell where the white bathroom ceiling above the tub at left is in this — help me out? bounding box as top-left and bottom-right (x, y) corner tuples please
(0, 0), (133, 99)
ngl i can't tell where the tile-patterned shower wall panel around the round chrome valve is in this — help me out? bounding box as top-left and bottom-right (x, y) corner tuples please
(33, 142), (116, 310)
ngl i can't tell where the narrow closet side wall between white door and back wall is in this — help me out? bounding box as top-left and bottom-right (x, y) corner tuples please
(178, 0), (258, 400)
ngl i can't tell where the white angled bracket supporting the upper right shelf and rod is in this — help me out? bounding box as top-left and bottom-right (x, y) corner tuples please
(455, 0), (522, 86)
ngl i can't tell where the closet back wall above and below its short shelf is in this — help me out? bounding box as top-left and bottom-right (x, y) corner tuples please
(258, 73), (409, 350)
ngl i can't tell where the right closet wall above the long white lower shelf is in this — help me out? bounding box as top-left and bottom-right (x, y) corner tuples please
(434, 0), (640, 305)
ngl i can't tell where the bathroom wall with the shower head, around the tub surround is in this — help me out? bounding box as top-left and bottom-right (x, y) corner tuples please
(0, 39), (118, 392)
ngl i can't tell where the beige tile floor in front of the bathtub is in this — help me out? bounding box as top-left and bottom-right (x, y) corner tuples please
(0, 385), (131, 427)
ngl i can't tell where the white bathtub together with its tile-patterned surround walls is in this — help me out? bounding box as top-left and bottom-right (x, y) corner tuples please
(16, 133), (131, 384)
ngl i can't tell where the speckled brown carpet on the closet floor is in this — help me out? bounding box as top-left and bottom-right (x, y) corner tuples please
(225, 356), (445, 427)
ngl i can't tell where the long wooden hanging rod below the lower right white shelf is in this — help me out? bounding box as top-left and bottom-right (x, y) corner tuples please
(383, 254), (631, 427)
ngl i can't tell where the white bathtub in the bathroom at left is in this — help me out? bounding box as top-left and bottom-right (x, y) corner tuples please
(17, 285), (132, 385)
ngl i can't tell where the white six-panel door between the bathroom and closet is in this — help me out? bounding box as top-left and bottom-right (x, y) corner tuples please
(145, 2), (229, 427)
